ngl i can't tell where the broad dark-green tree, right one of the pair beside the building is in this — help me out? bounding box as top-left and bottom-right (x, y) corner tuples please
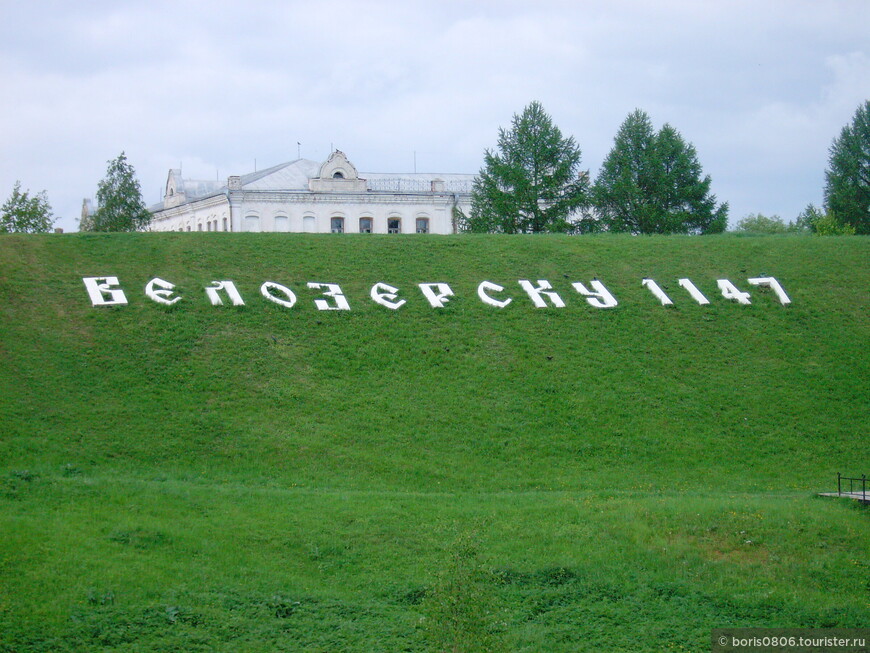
(592, 109), (728, 234)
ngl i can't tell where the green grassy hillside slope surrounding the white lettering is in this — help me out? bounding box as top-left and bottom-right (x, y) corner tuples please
(0, 234), (870, 652)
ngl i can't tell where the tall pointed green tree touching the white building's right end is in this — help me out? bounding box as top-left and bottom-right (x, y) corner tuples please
(465, 102), (589, 233)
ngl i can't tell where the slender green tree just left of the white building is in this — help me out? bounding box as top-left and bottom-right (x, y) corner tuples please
(93, 152), (151, 231)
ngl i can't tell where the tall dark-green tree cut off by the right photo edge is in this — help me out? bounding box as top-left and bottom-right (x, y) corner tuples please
(825, 100), (870, 234)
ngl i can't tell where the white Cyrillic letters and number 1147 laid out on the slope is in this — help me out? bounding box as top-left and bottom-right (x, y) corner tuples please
(82, 276), (791, 311)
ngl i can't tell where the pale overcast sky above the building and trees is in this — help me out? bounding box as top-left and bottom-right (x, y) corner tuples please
(0, 0), (870, 231)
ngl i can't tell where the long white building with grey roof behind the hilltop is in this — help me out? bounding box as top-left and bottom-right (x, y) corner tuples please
(150, 150), (474, 234)
